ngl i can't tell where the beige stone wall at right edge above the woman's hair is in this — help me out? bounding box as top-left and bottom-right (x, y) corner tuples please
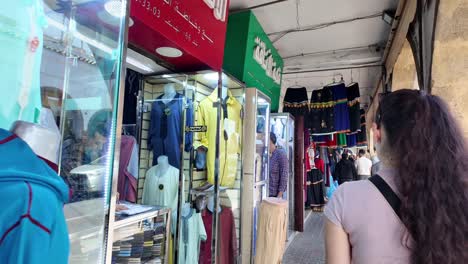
(432, 0), (468, 139)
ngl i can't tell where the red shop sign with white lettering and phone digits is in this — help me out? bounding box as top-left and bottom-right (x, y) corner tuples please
(129, 0), (229, 71)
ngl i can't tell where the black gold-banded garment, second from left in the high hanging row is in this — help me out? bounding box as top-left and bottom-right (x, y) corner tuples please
(308, 87), (335, 134)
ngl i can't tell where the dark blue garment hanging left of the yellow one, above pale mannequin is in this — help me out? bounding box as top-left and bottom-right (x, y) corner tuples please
(148, 93), (193, 168)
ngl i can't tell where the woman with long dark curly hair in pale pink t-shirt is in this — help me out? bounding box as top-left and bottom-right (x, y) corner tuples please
(325, 89), (468, 264)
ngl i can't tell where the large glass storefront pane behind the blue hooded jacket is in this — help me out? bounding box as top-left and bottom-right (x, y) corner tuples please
(0, 0), (127, 263)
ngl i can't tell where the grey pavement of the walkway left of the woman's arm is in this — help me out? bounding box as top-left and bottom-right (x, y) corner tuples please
(283, 213), (325, 264)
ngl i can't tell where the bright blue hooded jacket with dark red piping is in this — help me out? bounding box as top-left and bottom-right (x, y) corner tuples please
(0, 129), (70, 264)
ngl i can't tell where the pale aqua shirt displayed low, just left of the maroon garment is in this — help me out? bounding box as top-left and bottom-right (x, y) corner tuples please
(177, 208), (206, 264)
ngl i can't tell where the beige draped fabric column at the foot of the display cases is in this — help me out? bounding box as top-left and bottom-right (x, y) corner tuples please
(255, 198), (288, 264)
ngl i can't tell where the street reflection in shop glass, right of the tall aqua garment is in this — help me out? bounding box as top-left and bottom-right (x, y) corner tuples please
(40, 0), (125, 263)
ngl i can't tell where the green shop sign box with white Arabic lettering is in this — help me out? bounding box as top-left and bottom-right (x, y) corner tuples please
(223, 11), (283, 111)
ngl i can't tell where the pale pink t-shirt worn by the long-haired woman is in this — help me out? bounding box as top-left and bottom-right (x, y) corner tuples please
(325, 168), (410, 264)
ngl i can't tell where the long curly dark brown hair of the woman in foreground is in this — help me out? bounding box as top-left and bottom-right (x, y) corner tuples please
(375, 90), (468, 264)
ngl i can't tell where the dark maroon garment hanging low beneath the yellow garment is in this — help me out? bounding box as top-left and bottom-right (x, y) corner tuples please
(199, 206), (238, 264)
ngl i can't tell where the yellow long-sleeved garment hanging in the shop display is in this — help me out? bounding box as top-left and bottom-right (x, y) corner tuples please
(194, 89), (242, 187)
